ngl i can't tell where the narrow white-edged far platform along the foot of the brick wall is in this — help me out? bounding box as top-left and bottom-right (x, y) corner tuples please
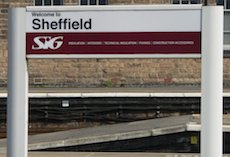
(0, 85), (230, 98)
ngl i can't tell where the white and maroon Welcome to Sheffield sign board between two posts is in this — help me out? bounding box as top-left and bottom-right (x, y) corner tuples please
(26, 5), (201, 58)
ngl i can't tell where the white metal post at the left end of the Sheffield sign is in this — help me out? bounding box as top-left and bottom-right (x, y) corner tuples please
(7, 8), (28, 157)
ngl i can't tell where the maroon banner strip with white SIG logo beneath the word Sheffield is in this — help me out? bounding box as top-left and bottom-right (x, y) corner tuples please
(26, 32), (201, 55)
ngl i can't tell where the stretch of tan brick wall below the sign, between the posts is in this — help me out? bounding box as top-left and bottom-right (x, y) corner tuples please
(29, 59), (200, 87)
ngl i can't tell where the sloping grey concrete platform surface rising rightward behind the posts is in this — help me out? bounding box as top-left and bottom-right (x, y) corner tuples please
(0, 115), (230, 152)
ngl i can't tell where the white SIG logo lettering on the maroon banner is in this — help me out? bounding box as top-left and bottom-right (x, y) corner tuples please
(32, 36), (63, 50)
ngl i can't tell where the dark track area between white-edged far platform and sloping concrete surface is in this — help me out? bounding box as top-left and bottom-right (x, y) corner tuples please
(0, 97), (230, 138)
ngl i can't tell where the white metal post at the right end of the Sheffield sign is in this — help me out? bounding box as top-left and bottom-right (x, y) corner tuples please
(201, 6), (223, 157)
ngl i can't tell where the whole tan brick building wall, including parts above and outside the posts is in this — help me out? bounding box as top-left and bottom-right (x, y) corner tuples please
(0, 0), (226, 87)
